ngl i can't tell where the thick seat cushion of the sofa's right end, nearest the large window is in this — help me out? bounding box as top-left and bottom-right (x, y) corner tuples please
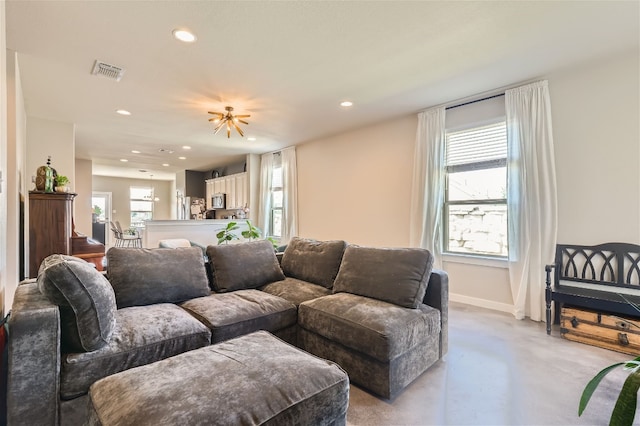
(298, 293), (440, 362)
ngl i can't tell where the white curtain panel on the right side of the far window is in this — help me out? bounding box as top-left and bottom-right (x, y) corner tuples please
(280, 146), (298, 244)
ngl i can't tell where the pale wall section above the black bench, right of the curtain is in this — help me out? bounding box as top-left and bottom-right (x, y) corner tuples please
(549, 51), (640, 245)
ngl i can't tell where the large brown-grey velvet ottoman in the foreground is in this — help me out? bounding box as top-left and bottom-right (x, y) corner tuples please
(89, 331), (349, 426)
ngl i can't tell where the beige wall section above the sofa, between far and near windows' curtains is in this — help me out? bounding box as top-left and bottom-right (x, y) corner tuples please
(296, 115), (418, 247)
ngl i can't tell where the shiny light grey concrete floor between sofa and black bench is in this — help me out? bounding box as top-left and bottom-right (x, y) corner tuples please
(347, 303), (640, 426)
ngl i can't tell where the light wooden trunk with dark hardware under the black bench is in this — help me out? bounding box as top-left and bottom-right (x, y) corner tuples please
(560, 307), (640, 356)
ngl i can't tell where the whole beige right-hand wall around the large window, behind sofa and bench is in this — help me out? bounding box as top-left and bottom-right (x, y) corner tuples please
(297, 47), (640, 311)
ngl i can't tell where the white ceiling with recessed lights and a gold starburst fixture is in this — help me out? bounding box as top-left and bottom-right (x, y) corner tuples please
(6, 0), (640, 179)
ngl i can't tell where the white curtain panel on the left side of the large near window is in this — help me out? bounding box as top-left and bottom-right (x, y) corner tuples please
(409, 107), (445, 268)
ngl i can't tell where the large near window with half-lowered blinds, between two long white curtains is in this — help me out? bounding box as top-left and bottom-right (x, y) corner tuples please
(443, 121), (508, 257)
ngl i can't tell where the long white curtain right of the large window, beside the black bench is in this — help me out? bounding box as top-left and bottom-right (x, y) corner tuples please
(505, 81), (557, 321)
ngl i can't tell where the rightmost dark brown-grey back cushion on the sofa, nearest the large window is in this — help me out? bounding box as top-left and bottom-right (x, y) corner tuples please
(333, 245), (433, 308)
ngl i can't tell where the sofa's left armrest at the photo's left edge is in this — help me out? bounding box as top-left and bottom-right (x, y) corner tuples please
(7, 283), (60, 425)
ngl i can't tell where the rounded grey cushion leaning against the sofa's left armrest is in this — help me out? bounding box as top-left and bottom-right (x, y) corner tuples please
(37, 254), (116, 352)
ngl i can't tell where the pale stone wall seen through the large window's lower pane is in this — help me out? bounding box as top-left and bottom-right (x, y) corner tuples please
(448, 204), (508, 256)
